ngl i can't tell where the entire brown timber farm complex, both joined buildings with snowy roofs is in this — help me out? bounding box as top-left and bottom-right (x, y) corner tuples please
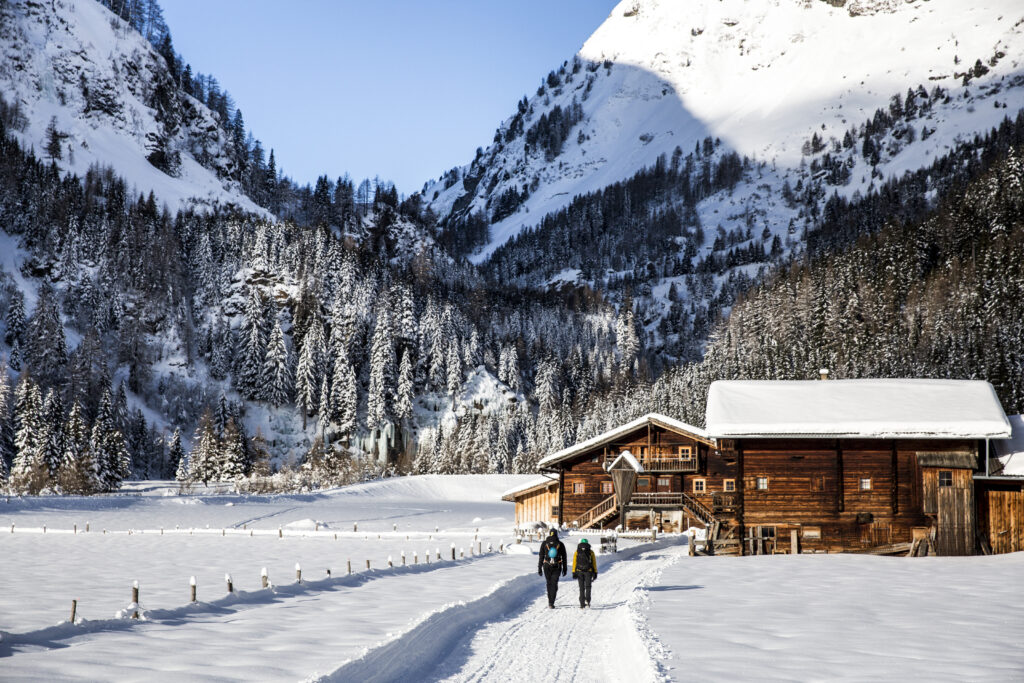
(540, 379), (1024, 555)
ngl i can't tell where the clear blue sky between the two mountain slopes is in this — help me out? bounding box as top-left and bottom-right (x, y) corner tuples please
(161, 0), (616, 194)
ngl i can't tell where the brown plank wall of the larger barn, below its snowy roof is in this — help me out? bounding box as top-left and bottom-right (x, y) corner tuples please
(737, 438), (962, 554)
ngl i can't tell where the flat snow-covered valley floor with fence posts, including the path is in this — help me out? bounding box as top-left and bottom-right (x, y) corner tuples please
(0, 476), (1024, 681)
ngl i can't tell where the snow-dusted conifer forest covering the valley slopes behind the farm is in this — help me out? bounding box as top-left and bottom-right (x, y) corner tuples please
(0, 0), (1024, 494)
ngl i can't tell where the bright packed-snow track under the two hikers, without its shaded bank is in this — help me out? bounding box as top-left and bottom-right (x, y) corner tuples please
(439, 545), (686, 682)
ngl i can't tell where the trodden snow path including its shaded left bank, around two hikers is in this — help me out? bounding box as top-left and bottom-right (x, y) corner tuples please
(323, 539), (686, 682)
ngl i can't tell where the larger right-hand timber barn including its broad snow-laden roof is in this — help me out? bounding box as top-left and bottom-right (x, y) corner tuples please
(707, 375), (1011, 555)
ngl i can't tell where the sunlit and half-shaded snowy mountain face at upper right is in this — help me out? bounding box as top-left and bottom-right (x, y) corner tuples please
(424, 0), (1024, 263)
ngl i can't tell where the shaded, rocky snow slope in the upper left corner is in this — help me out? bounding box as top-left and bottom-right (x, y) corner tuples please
(0, 0), (264, 213)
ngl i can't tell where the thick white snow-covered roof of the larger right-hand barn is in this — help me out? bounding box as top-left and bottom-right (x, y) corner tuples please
(706, 379), (1010, 438)
